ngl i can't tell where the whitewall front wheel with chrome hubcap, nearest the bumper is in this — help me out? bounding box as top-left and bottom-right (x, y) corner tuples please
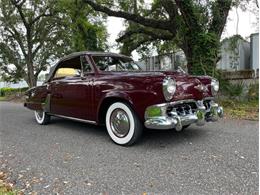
(106, 102), (143, 145)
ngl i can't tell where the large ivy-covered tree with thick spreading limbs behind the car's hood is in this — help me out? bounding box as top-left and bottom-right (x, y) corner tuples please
(84, 0), (232, 75)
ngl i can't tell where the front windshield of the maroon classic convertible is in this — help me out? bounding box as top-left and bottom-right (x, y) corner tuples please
(92, 56), (141, 71)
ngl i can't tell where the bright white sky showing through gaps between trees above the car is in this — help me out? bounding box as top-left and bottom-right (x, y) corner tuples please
(107, 5), (259, 60)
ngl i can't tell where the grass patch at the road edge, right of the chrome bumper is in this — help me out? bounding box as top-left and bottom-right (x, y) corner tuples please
(218, 99), (259, 121)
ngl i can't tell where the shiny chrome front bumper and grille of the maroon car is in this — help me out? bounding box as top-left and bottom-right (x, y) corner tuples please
(144, 98), (223, 131)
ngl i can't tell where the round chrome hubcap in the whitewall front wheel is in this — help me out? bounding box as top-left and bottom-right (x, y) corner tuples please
(110, 108), (130, 138)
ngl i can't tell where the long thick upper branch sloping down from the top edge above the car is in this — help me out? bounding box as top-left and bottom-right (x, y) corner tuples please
(84, 0), (172, 30)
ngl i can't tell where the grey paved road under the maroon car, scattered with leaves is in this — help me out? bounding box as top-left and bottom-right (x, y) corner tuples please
(0, 102), (258, 194)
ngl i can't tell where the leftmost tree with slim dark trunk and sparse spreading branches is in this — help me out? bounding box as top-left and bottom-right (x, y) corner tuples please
(0, 0), (66, 87)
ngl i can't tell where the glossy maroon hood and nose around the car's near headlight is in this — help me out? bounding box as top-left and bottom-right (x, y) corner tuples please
(98, 71), (211, 102)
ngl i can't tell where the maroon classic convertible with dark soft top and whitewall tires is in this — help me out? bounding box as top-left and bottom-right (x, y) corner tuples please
(24, 51), (223, 145)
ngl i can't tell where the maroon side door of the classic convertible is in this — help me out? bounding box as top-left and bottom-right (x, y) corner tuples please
(50, 55), (94, 120)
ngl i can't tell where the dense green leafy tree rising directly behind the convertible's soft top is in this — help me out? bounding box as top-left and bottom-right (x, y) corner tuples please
(58, 0), (107, 51)
